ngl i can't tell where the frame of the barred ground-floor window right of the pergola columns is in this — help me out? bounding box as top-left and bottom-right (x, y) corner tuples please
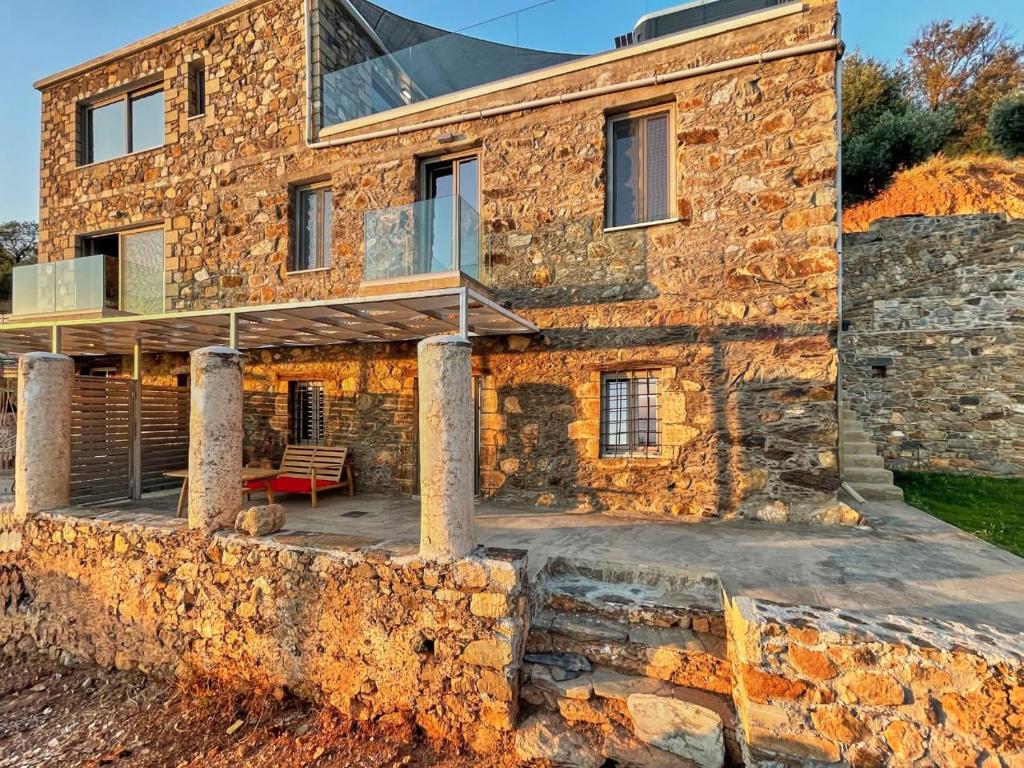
(598, 368), (665, 459)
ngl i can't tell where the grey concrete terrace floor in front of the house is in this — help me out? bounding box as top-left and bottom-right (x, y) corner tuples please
(59, 492), (1024, 633)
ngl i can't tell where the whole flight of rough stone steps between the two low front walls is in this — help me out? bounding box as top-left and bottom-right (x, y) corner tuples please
(517, 559), (741, 768)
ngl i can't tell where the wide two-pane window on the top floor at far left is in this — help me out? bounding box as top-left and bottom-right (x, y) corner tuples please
(82, 88), (164, 164)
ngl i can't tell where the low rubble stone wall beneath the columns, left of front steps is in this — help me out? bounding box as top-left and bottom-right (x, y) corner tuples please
(0, 507), (527, 745)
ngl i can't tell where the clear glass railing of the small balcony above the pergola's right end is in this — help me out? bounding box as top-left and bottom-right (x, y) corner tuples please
(362, 197), (483, 281)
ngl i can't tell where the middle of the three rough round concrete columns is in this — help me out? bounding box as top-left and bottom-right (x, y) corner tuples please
(188, 346), (242, 531)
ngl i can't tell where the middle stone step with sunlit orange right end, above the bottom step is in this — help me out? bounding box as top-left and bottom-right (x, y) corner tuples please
(526, 610), (732, 694)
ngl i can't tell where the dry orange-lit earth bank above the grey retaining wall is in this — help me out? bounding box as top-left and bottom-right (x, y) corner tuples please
(843, 156), (1024, 232)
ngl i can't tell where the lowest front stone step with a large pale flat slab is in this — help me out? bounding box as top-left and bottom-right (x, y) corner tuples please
(520, 656), (741, 768)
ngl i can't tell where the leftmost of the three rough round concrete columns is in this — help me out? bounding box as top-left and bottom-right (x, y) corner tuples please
(14, 352), (75, 518)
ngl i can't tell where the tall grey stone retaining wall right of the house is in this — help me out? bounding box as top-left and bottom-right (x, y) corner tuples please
(842, 215), (1024, 476)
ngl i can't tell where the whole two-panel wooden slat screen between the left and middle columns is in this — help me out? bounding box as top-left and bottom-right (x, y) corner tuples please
(71, 376), (189, 504)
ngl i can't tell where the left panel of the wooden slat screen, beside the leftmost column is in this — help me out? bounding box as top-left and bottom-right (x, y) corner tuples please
(71, 376), (134, 504)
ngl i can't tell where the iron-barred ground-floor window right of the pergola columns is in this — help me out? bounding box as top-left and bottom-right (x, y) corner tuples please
(601, 371), (662, 457)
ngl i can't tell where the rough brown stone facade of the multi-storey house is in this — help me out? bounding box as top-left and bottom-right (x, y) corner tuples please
(41, 0), (839, 519)
